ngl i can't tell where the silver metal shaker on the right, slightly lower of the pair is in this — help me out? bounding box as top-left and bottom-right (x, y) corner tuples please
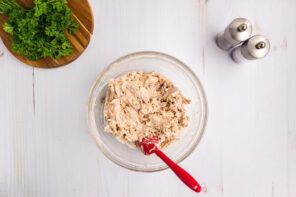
(231, 35), (270, 63)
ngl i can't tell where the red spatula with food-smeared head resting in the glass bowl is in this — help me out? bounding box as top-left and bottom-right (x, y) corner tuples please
(139, 137), (201, 192)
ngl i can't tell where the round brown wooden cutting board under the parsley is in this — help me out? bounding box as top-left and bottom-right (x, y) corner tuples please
(0, 0), (94, 68)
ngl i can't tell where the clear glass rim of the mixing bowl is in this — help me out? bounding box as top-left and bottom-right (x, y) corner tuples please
(87, 51), (208, 172)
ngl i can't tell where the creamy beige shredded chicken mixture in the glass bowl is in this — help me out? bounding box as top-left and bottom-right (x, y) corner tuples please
(104, 72), (190, 148)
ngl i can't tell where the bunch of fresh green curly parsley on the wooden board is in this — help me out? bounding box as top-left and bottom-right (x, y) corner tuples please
(0, 0), (79, 60)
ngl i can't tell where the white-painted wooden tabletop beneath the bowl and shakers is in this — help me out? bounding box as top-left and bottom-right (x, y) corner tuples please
(0, 0), (296, 197)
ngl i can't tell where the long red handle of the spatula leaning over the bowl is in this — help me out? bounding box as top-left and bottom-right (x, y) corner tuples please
(155, 149), (201, 192)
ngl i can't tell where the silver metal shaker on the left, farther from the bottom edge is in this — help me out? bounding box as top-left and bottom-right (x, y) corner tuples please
(216, 18), (252, 50)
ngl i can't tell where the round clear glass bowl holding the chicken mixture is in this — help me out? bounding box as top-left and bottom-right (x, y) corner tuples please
(88, 51), (207, 172)
